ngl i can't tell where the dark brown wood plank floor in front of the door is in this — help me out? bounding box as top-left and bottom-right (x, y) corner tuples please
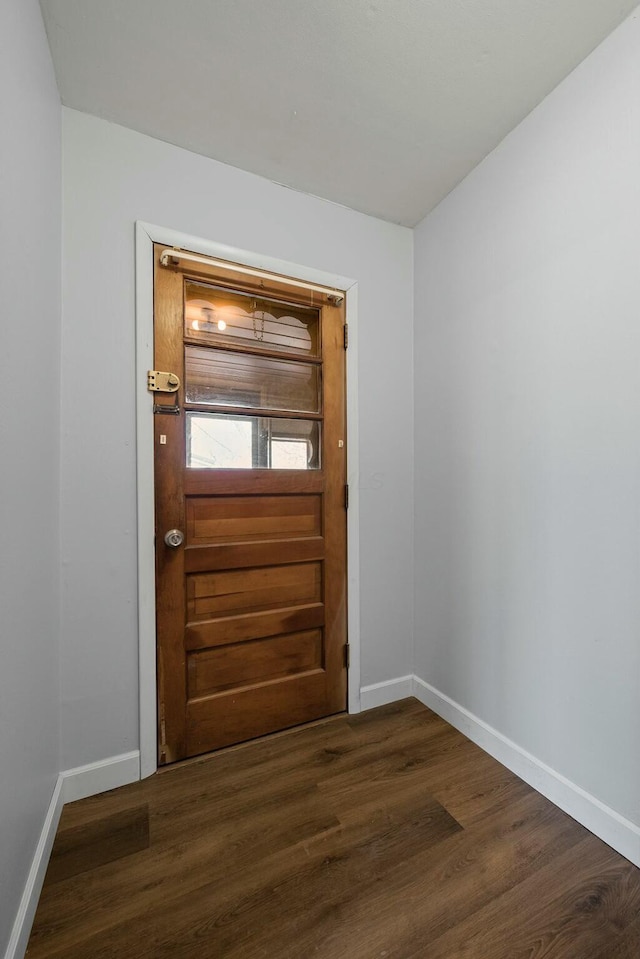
(27, 700), (640, 959)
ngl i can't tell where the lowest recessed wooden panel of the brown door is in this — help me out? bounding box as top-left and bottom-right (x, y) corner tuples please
(187, 629), (322, 699)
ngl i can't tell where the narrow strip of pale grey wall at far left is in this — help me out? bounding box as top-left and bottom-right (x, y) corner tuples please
(0, 0), (61, 954)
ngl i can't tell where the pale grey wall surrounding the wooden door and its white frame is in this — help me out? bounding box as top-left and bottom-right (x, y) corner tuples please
(61, 110), (413, 768)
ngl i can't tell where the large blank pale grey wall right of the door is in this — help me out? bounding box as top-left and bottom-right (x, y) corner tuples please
(415, 7), (640, 824)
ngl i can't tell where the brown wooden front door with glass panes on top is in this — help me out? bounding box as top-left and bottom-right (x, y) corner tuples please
(154, 246), (347, 763)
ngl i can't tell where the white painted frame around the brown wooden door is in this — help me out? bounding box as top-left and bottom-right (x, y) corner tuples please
(135, 220), (360, 779)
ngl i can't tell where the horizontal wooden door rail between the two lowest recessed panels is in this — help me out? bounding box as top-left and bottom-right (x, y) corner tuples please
(185, 603), (324, 650)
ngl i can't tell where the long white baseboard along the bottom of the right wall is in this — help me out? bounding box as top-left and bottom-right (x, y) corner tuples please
(413, 676), (640, 866)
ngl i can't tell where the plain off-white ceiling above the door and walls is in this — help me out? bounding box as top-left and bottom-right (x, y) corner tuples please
(41, 0), (637, 226)
